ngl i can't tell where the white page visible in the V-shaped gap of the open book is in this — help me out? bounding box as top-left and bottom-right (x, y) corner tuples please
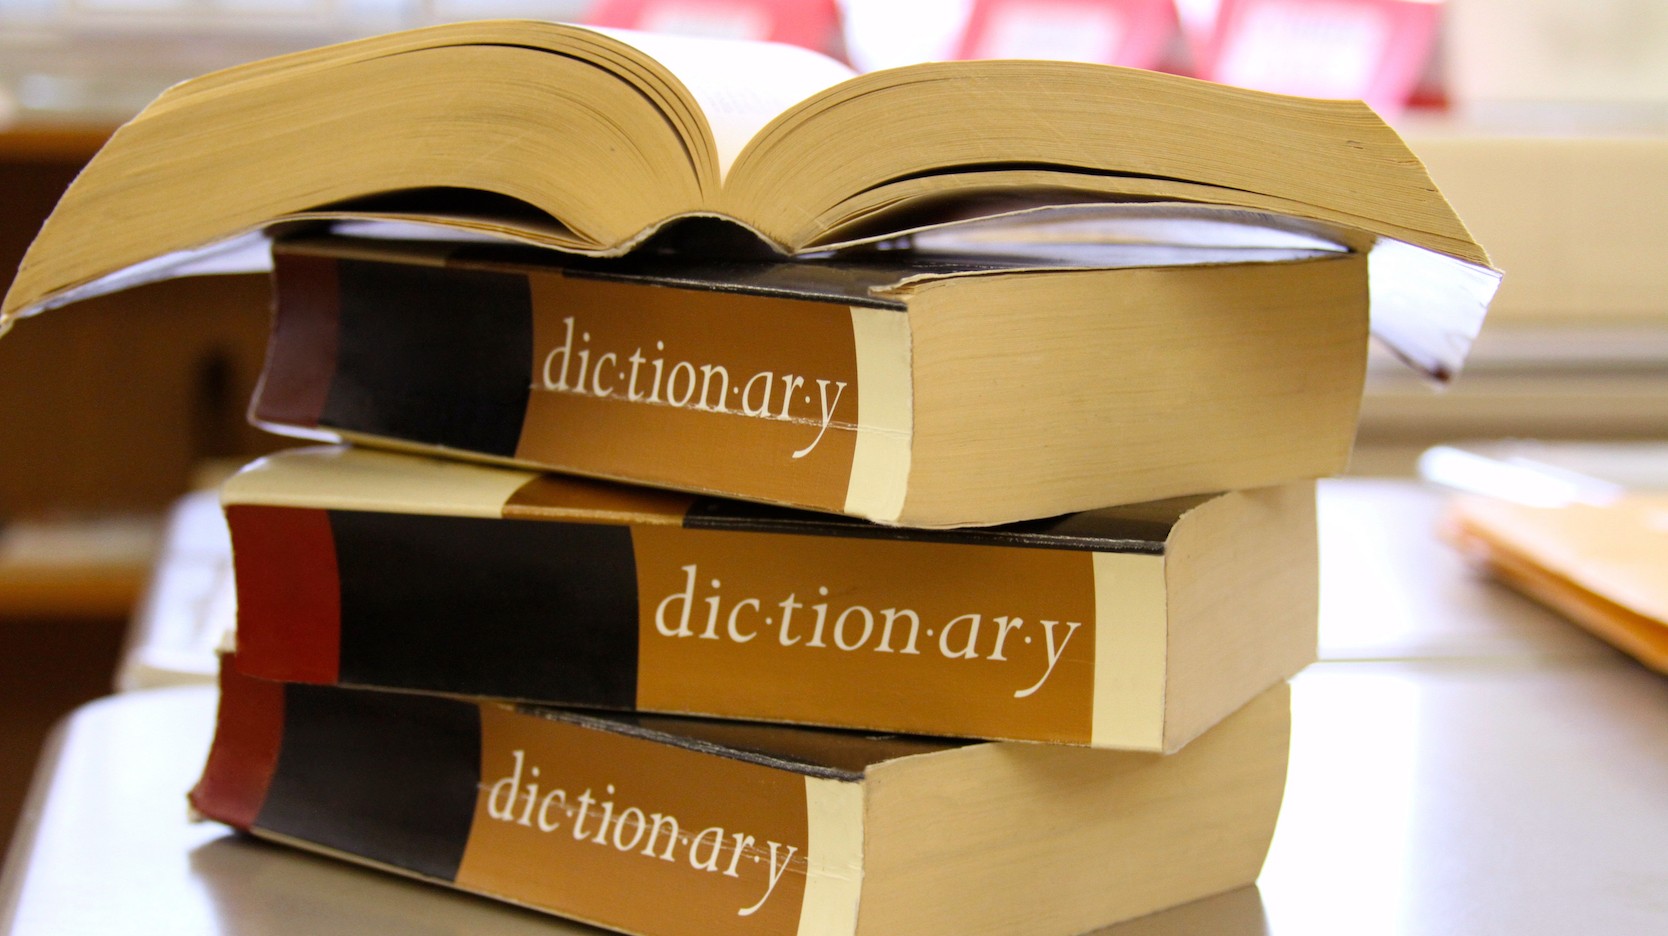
(597, 28), (857, 174)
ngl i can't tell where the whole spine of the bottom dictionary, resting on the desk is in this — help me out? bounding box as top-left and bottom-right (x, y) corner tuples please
(192, 669), (862, 934)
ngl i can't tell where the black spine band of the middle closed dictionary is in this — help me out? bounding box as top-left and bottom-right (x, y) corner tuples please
(330, 511), (637, 707)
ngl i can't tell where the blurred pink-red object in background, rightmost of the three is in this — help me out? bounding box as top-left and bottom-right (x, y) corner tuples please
(1199, 0), (1441, 113)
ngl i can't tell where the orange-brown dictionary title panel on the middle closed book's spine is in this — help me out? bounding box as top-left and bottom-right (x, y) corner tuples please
(632, 527), (1096, 742)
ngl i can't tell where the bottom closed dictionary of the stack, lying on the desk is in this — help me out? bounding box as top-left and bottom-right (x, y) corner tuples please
(192, 657), (1291, 936)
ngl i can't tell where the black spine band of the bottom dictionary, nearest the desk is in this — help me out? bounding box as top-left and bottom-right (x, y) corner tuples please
(255, 684), (480, 881)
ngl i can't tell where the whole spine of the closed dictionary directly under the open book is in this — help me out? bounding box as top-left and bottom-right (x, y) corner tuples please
(252, 252), (911, 521)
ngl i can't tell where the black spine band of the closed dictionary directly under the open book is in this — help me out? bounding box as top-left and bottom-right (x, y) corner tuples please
(321, 260), (532, 457)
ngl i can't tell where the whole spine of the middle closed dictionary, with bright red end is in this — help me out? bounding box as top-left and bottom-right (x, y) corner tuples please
(227, 496), (1169, 747)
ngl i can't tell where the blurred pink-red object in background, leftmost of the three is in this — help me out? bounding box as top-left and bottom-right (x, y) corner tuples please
(585, 0), (839, 52)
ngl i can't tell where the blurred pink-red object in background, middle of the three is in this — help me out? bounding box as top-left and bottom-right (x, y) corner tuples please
(957, 0), (1176, 68)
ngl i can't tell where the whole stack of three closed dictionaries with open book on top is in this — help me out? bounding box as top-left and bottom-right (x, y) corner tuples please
(5, 16), (1496, 934)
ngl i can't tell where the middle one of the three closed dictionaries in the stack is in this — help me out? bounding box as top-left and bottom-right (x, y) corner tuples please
(222, 449), (1318, 751)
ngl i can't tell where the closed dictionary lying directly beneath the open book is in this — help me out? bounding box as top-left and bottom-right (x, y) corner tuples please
(252, 237), (1368, 527)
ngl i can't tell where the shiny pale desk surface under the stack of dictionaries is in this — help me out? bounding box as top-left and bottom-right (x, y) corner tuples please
(0, 481), (1668, 936)
